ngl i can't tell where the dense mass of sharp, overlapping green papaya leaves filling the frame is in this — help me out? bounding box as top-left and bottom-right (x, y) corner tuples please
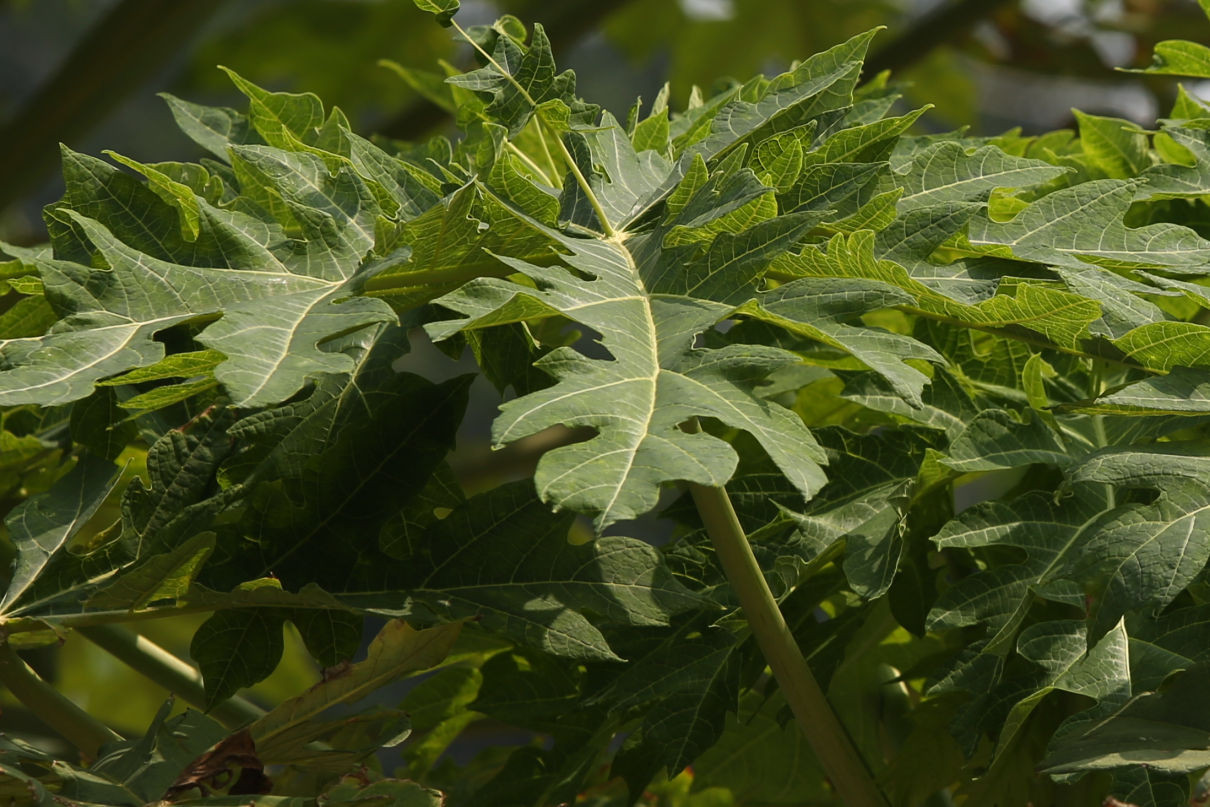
(0, 0), (1210, 807)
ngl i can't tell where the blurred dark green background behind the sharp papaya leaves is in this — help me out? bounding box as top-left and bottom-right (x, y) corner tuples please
(0, 0), (1210, 774)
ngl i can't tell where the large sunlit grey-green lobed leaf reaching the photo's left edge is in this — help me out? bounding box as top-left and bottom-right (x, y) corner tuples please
(0, 146), (393, 405)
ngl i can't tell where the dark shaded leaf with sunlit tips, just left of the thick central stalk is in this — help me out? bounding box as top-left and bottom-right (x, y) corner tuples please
(375, 483), (702, 661)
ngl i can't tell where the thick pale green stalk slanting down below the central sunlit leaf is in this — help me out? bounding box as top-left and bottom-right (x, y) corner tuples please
(688, 422), (887, 807)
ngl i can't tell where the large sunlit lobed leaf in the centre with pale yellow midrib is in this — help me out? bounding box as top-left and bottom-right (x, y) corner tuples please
(427, 198), (823, 529)
